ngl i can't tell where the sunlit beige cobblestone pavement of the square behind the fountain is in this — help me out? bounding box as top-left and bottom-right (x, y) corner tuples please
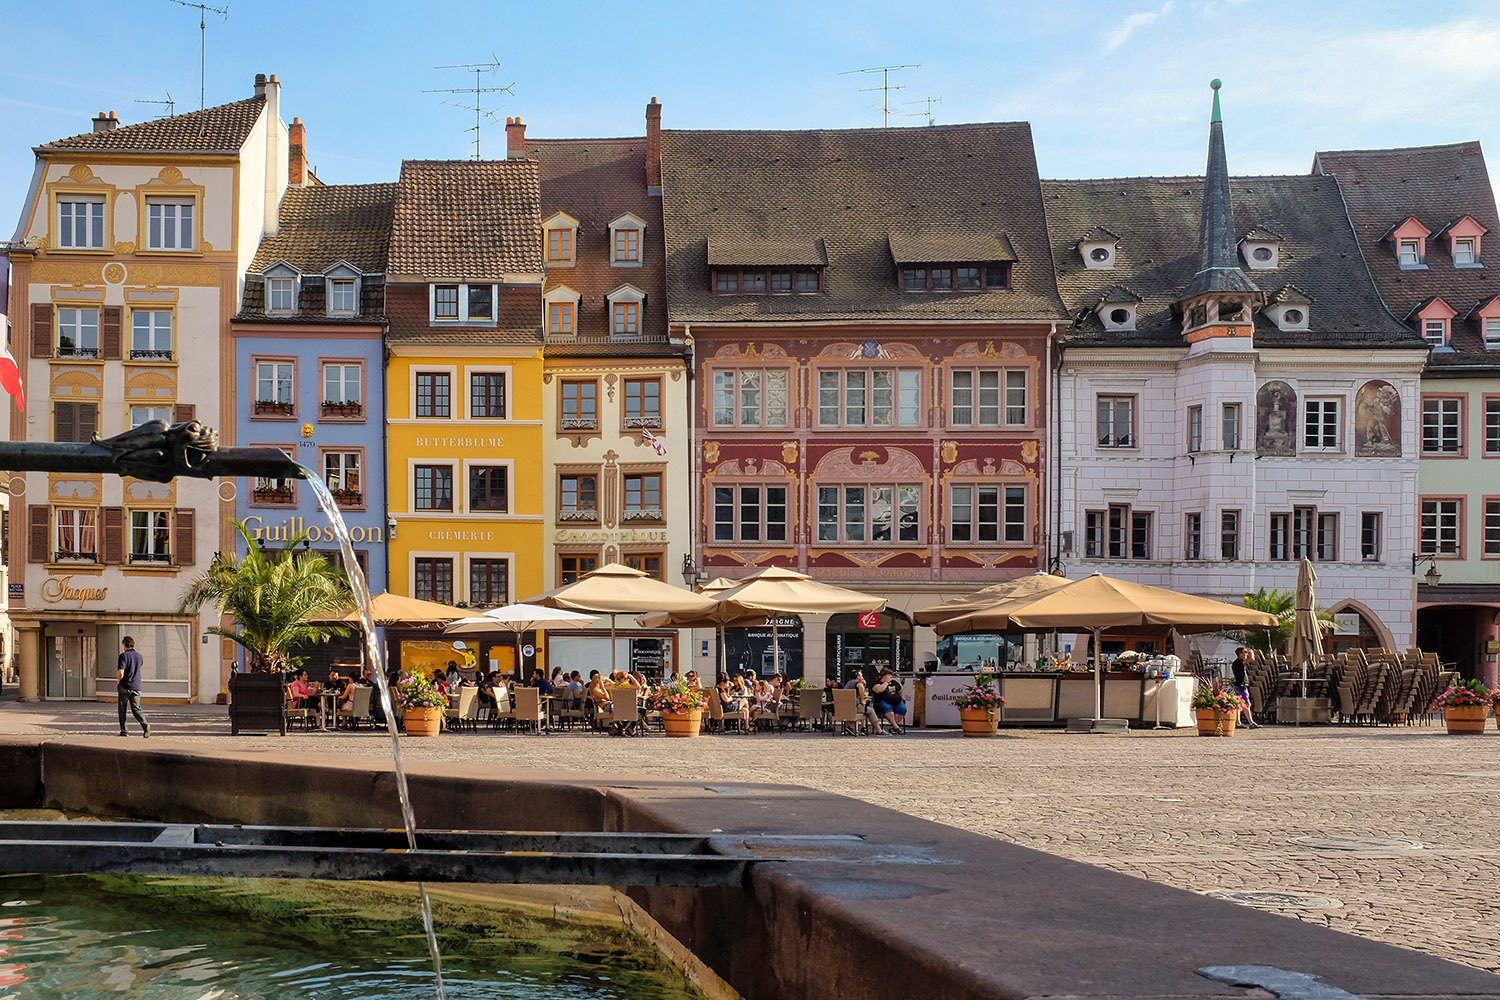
(0, 700), (1500, 972)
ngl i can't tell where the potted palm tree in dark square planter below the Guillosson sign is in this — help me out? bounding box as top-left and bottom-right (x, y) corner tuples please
(177, 522), (354, 733)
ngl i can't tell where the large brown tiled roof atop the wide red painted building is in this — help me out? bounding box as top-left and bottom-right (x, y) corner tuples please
(662, 123), (1062, 322)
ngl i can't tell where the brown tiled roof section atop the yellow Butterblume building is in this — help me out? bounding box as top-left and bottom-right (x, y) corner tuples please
(389, 160), (542, 282)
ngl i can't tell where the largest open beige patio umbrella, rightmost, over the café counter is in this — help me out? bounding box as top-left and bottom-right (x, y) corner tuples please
(1005, 573), (1280, 723)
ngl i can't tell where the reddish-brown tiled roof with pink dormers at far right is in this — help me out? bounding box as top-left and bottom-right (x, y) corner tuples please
(1313, 142), (1500, 369)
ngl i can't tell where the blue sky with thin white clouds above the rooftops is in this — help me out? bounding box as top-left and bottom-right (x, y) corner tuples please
(0, 0), (1500, 229)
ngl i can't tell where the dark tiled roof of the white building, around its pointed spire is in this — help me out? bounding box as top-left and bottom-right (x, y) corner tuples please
(1043, 177), (1422, 348)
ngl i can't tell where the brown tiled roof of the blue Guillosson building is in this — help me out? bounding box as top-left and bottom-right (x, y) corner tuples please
(251, 184), (396, 274)
